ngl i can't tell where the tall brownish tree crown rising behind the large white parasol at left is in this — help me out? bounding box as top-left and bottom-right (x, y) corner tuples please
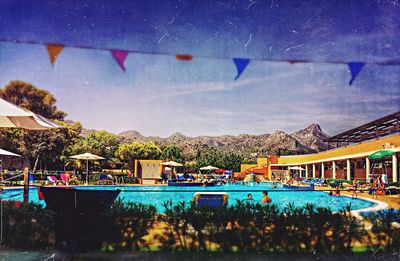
(0, 80), (67, 120)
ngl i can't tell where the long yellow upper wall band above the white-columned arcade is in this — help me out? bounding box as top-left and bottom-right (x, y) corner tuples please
(278, 134), (400, 164)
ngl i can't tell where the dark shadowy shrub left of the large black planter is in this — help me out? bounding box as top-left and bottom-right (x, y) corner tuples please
(3, 202), (54, 249)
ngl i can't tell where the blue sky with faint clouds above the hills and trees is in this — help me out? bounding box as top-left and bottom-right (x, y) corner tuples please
(0, 0), (400, 136)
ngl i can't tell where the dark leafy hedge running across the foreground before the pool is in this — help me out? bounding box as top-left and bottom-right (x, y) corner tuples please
(3, 200), (400, 254)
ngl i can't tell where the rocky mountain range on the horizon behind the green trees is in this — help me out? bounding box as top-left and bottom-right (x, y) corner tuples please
(111, 123), (329, 158)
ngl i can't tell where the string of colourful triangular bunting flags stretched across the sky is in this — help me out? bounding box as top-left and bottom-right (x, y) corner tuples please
(0, 39), (400, 85)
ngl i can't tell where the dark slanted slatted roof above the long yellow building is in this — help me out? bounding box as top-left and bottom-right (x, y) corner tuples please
(324, 111), (400, 143)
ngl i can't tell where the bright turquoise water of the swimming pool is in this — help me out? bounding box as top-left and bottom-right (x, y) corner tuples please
(3, 183), (374, 211)
